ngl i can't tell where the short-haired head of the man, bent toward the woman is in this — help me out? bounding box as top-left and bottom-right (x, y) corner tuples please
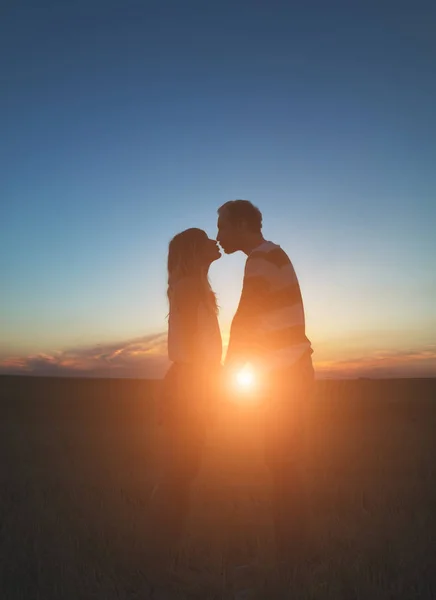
(216, 200), (262, 254)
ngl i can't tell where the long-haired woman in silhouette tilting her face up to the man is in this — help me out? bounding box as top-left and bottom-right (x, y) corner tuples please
(150, 229), (222, 575)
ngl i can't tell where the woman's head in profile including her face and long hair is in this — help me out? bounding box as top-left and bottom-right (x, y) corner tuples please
(168, 228), (221, 309)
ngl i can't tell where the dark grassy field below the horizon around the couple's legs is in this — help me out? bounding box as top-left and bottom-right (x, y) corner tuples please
(0, 376), (436, 600)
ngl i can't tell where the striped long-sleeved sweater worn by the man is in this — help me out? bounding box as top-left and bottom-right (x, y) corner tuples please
(226, 241), (312, 371)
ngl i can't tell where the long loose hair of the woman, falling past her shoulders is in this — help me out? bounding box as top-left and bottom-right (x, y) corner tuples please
(167, 228), (218, 314)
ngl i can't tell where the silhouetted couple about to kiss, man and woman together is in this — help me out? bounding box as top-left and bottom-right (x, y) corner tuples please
(150, 200), (314, 592)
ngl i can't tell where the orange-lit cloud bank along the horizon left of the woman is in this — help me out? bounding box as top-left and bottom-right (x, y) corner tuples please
(0, 333), (168, 378)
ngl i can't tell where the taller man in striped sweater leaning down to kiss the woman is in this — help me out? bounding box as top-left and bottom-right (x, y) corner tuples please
(217, 200), (314, 573)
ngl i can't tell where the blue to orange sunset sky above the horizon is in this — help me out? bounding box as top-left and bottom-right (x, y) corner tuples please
(0, 0), (436, 377)
